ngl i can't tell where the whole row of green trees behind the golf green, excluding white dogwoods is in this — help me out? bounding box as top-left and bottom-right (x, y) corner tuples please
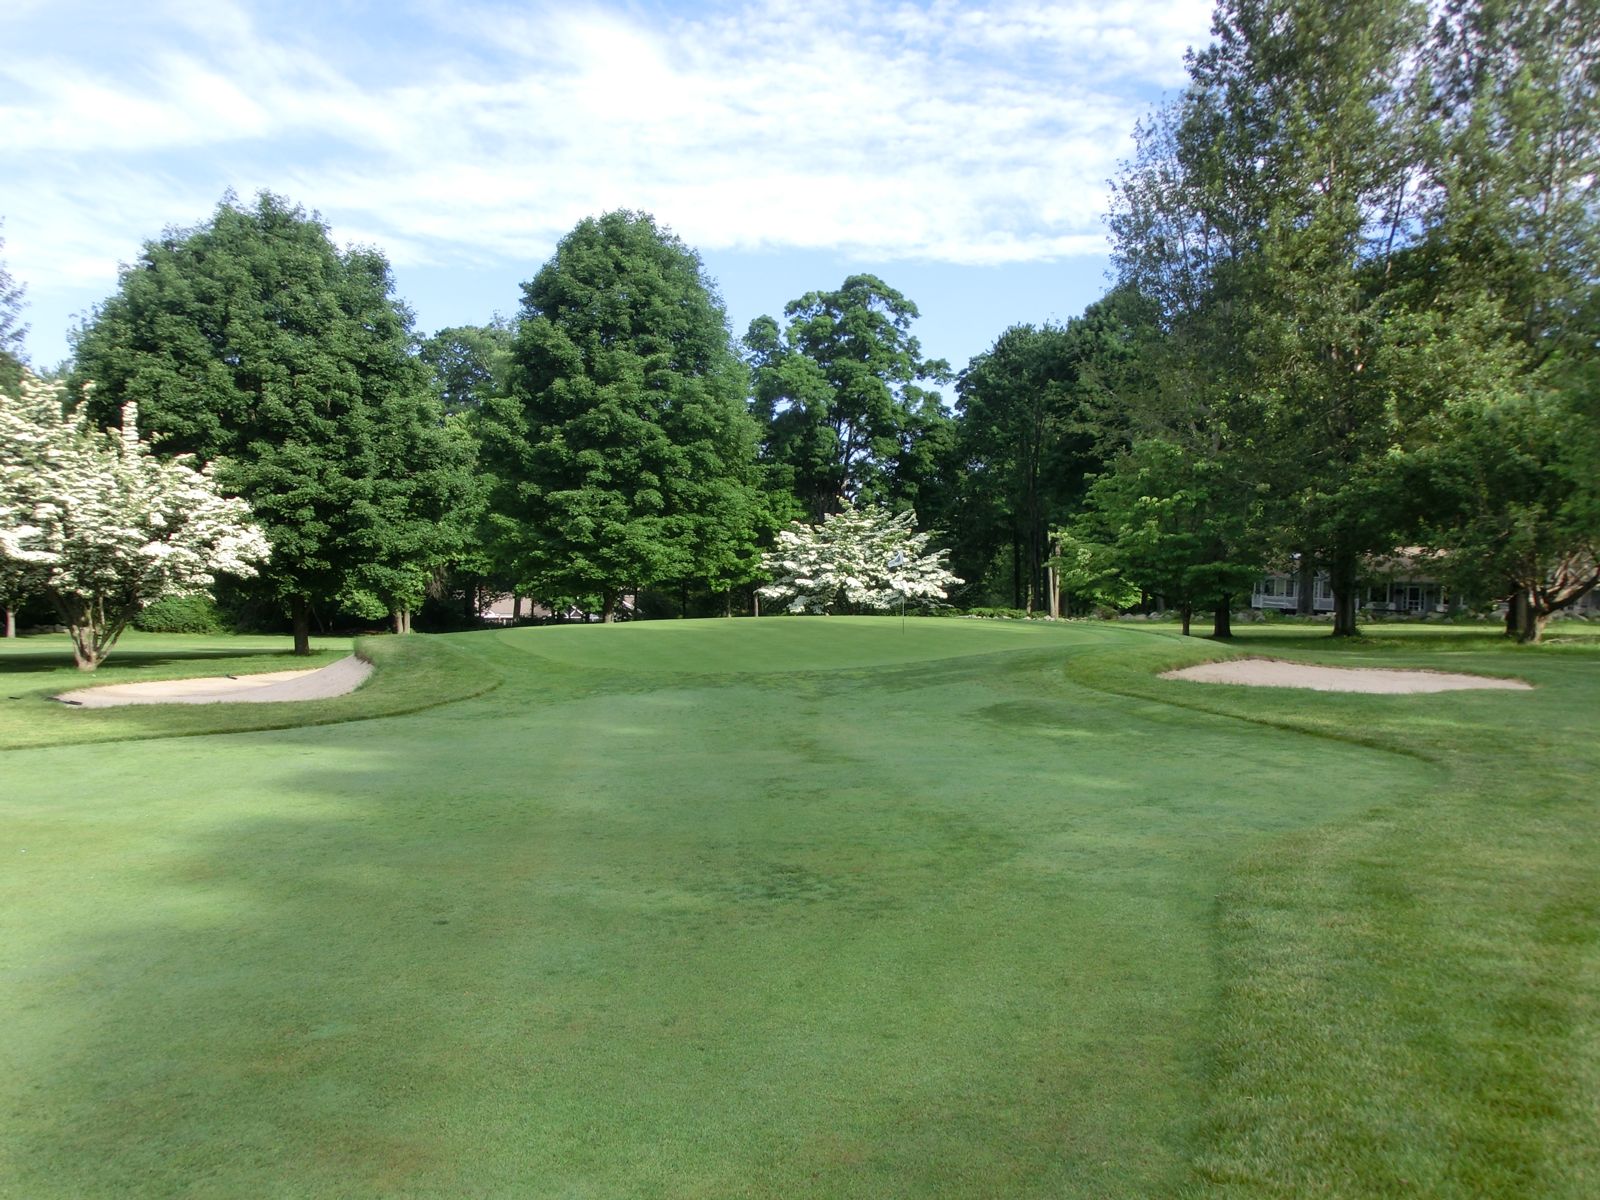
(0, 0), (1600, 650)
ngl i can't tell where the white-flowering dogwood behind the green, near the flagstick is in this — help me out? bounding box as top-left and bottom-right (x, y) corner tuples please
(757, 504), (962, 614)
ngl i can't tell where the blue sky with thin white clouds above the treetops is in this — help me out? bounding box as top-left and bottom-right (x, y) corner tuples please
(0, 0), (1210, 380)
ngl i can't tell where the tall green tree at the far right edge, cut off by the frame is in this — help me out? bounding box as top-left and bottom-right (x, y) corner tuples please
(1413, 0), (1600, 642)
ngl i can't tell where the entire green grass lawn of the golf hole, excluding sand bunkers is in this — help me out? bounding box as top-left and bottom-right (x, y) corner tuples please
(0, 618), (1600, 1200)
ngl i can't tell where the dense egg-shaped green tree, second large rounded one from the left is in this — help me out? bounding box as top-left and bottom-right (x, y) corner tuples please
(482, 211), (766, 619)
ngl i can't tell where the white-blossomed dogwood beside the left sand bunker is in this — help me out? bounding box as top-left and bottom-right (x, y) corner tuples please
(0, 376), (270, 670)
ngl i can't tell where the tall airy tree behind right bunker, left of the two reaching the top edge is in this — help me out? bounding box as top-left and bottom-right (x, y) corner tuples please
(1112, 0), (1430, 635)
